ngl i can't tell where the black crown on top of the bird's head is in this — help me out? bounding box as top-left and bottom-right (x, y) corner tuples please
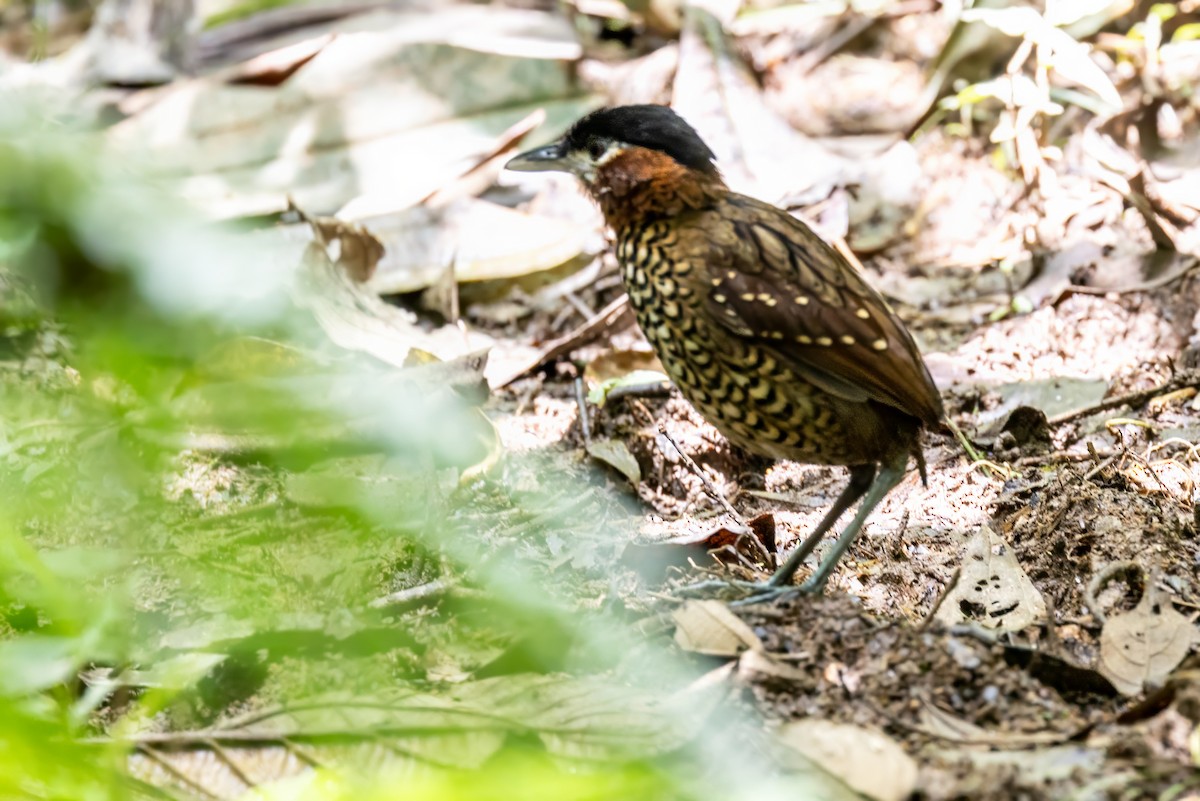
(566, 104), (716, 173)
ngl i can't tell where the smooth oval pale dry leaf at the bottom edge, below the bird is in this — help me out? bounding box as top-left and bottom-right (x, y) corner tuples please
(778, 718), (917, 801)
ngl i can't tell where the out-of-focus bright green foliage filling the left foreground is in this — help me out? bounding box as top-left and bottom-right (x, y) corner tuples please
(0, 95), (796, 799)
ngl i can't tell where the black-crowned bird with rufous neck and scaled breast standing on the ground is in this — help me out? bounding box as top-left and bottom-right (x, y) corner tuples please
(506, 104), (944, 598)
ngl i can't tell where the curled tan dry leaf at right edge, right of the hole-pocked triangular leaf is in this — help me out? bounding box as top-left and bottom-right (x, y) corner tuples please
(1097, 580), (1200, 695)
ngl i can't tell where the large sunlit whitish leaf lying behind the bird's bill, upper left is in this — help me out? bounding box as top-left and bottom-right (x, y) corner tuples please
(109, 6), (594, 218)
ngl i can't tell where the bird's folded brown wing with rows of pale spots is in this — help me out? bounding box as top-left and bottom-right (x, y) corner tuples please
(707, 195), (944, 426)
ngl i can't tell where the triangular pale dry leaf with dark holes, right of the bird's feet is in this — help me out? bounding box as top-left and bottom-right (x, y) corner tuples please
(937, 525), (1046, 632)
